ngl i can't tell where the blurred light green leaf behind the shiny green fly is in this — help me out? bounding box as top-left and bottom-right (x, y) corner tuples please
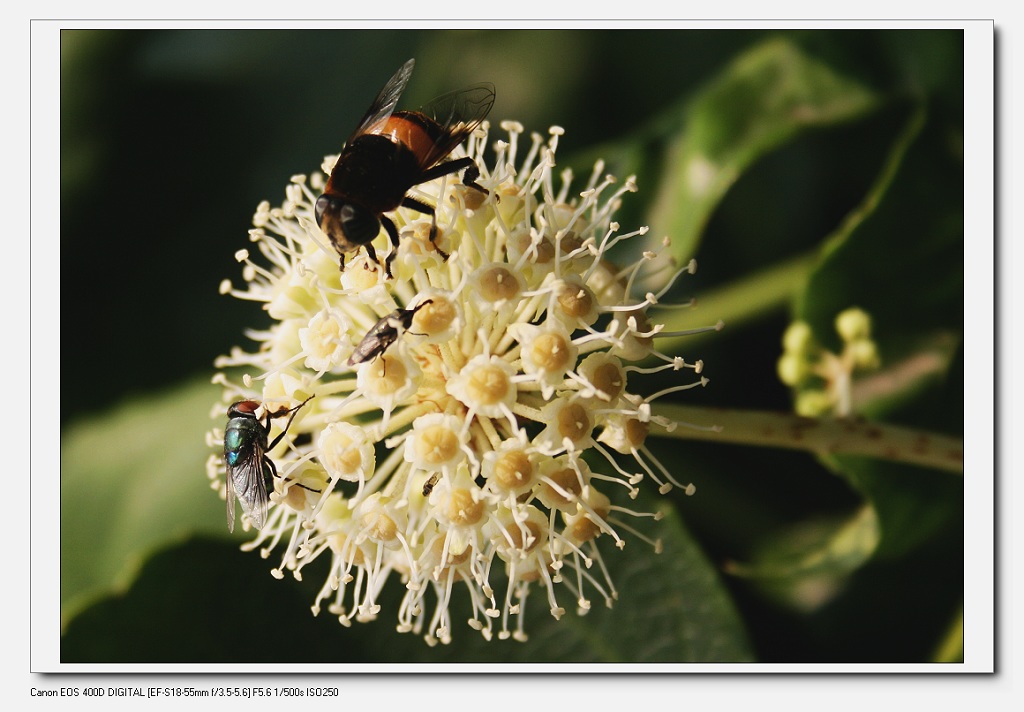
(60, 381), (227, 623)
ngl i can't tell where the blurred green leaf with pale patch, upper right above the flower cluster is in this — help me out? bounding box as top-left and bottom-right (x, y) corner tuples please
(601, 38), (879, 262)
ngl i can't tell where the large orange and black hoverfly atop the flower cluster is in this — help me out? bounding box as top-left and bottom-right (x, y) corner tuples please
(315, 59), (495, 277)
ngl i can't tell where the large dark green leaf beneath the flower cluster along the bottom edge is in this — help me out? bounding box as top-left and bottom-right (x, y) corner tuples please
(61, 487), (753, 664)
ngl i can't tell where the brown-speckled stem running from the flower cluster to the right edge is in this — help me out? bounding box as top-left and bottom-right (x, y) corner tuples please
(651, 404), (964, 474)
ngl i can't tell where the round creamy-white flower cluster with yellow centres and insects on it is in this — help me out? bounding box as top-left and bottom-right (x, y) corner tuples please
(208, 122), (706, 643)
